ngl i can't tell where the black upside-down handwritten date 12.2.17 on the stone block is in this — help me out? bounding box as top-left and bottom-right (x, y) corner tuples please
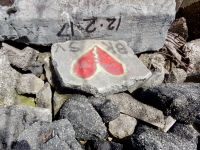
(57, 17), (121, 36)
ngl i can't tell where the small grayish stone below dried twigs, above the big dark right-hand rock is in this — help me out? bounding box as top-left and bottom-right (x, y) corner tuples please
(164, 68), (187, 83)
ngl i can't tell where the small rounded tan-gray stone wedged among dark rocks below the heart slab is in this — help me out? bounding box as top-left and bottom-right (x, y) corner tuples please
(109, 114), (137, 139)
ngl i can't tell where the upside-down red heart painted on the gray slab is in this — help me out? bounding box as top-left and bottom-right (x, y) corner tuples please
(73, 46), (124, 78)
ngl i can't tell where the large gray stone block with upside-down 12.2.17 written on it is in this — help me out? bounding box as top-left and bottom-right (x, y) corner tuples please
(0, 0), (176, 53)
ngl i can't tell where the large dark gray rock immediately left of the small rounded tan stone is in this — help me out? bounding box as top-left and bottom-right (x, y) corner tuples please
(59, 95), (107, 140)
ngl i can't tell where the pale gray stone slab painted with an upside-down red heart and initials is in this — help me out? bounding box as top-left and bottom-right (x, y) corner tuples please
(51, 40), (151, 95)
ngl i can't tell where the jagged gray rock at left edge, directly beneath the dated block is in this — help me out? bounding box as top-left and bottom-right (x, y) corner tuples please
(1, 43), (39, 70)
